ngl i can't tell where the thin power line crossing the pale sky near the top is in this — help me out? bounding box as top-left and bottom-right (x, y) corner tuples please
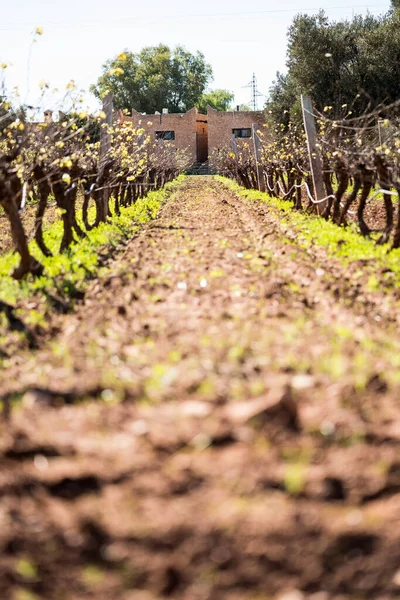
(0, 4), (389, 31)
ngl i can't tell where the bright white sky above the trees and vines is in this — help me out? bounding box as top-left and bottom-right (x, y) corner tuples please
(0, 0), (390, 116)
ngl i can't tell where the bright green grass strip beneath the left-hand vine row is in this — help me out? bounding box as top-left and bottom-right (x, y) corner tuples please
(0, 176), (184, 347)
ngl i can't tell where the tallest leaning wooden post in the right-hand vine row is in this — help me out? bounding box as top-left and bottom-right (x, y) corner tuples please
(301, 96), (327, 215)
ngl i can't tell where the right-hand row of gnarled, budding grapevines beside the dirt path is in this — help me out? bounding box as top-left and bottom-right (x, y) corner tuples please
(214, 107), (400, 248)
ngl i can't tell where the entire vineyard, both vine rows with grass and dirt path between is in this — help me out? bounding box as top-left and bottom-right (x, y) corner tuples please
(0, 95), (400, 600)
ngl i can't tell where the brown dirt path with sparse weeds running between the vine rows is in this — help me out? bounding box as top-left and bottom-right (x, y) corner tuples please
(0, 177), (400, 600)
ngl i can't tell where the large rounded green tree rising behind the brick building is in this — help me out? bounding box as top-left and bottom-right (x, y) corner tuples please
(91, 44), (212, 114)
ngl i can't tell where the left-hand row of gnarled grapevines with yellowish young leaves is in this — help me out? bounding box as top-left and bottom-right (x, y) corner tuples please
(0, 95), (188, 279)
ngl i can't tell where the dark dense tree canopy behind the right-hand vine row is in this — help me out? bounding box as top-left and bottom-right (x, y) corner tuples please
(267, 0), (400, 125)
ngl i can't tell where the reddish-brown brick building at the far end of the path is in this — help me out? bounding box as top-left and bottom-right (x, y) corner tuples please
(119, 106), (265, 163)
